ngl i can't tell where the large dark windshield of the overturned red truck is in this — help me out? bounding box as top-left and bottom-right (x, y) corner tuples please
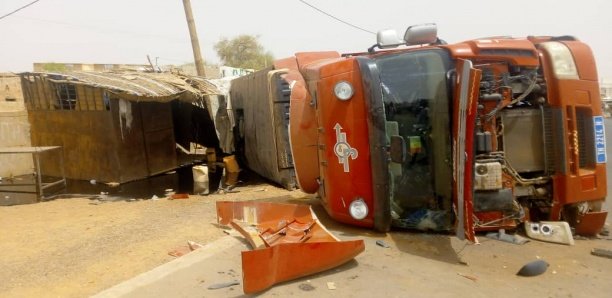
(375, 49), (452, 230)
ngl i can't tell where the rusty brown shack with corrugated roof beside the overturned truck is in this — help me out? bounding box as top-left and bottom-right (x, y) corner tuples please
(20, 72), (219, 182)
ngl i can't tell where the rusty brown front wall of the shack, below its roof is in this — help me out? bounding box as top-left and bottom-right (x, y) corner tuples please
(22, 76), (172, 182)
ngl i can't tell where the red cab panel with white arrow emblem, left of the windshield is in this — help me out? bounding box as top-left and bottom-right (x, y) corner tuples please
(317, 58), (374, 227)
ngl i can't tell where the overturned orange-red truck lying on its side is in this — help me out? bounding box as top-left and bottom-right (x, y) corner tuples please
(230, 24), (607, 240)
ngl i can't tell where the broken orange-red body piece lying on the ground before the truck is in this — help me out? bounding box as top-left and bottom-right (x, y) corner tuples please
(217, 201), (365, 294)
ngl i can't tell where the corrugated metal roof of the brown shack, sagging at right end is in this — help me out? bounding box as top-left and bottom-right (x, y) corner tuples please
(20, 71), (221, 102)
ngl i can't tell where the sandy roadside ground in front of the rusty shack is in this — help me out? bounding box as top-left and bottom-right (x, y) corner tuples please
(0, 185), (304, 297)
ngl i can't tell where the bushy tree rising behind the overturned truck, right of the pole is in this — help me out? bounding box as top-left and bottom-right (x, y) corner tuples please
(214, 34), (274, 70)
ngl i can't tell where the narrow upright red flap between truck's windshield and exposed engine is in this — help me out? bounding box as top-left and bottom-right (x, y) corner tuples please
(452, 59), (481, 242)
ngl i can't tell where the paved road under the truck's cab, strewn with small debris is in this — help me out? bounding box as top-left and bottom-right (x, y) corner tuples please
(97, 206), (612, 298)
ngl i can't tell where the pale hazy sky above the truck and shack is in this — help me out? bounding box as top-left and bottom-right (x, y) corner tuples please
(0, 0), (612, 79)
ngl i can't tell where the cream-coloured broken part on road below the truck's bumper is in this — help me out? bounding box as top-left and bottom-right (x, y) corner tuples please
(525, 221), (574, 245)
